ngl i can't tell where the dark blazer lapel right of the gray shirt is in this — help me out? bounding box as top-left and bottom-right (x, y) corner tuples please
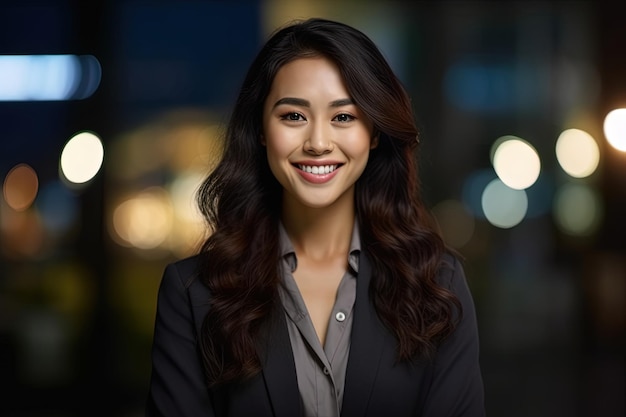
(341, 252), (389, 417)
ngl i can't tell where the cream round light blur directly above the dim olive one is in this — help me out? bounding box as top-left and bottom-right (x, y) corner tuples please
(556, 129), (600, 178)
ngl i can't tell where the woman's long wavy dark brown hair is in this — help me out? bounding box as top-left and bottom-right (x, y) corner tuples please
(198, 19), (460, 384)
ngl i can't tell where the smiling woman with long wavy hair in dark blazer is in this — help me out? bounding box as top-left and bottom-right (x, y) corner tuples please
(147, 19), (484, 417)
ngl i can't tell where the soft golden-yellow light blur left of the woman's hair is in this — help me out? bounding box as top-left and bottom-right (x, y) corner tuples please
(113, 187), (173, 249)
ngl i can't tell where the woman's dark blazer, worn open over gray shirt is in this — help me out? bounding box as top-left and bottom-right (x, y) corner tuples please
(146, 255), (485, 417)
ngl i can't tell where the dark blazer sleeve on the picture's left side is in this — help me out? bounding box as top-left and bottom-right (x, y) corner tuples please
(146, 264), (214, 417)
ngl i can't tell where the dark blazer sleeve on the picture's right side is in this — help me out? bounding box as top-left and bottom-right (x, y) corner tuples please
(423, 254), (485, 417)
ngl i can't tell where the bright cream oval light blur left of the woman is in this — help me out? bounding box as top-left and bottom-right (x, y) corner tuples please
(61, 132), (104, 184)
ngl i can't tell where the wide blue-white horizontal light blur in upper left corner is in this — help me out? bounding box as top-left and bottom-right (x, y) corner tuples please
(0, 55), (102, 101)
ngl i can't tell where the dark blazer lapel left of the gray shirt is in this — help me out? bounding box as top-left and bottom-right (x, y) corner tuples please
(263, 309), (303, 417)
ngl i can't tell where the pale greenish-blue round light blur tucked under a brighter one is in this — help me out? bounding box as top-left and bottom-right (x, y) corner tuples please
(482, 179), (528, 229)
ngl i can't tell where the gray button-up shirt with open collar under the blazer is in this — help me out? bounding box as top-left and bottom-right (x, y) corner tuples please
(280, 222), (361, 417)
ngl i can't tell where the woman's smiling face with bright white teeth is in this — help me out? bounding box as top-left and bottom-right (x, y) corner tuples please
(262, 57), (375, 208)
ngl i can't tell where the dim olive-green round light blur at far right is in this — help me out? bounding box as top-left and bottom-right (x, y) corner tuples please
(554, 184), (603, 236)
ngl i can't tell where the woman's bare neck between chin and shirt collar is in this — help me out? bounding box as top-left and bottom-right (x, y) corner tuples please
(282, 195), (355, 260)
